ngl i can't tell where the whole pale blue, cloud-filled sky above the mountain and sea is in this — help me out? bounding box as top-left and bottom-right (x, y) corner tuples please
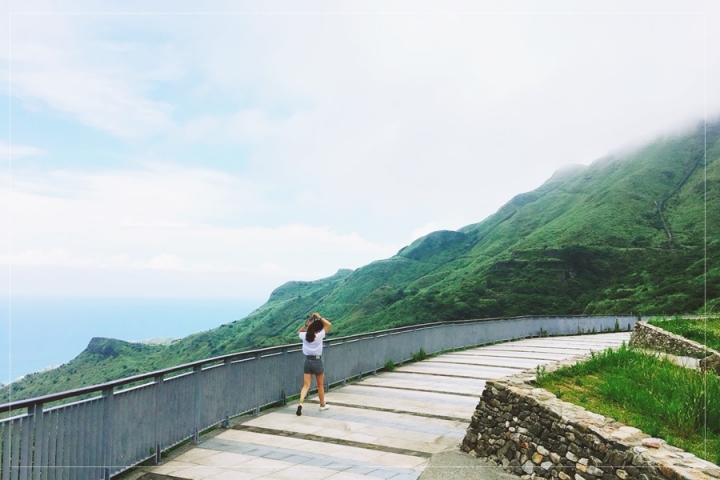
(0, 0), (720, 301)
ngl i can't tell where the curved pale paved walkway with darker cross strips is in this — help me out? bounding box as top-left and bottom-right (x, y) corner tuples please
(140, 332), (630, 480)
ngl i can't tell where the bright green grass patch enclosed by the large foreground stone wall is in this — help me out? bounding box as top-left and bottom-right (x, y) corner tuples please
(537, 345), (720, 464)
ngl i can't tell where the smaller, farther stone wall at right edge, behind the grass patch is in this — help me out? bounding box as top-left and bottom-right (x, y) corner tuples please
(630, 322), (720, 375)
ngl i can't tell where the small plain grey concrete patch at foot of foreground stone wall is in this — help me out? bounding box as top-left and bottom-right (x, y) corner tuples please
(418, 447), (520, 480)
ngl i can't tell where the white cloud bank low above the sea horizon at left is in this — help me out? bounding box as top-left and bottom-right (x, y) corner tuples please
(0, 165), (402, 296)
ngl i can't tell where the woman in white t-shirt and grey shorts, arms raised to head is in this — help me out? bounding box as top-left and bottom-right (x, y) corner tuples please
(295, 312), (332, 416)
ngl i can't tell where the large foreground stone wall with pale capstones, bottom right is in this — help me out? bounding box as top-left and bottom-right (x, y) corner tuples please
(461, 358), (720, 480)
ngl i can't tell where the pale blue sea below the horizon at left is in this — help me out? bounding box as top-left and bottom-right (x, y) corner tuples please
(0, 297), (264, 384)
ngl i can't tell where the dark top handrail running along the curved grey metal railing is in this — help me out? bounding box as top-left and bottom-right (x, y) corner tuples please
(0, 314), (635, 413)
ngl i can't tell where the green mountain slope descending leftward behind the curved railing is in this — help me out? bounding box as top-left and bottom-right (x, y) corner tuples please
(0, 120), (720, 401)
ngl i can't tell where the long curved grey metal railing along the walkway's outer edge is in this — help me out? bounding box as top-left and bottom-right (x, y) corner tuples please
(0, 316), (637, 480)
